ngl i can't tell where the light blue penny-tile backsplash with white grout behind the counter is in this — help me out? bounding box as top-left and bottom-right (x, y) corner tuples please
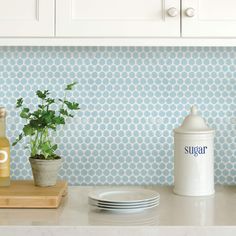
(0, 47), (236, 185)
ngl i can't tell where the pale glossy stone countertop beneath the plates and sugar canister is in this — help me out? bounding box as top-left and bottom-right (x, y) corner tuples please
(0, 186), (236, 236)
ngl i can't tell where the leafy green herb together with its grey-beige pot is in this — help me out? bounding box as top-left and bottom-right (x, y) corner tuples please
(13, 82), (80, 187)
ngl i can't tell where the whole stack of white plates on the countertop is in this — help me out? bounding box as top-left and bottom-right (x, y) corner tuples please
(89, 189), (160, 212)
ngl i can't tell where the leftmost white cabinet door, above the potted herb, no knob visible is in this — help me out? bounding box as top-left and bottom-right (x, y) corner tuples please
(0, 0), (54, 37)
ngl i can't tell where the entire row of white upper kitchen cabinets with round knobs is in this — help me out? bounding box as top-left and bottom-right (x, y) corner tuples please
(0, 0), (236, 46)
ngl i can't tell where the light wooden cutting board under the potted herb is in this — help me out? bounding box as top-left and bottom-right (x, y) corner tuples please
(0, 180), (67, 208)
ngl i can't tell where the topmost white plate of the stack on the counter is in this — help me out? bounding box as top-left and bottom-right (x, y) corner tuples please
(89, 189), (160, 204)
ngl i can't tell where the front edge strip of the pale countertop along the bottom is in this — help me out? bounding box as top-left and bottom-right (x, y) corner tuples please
(0, 225), (236, 236)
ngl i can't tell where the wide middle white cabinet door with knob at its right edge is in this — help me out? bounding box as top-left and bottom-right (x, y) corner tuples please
(56, 0), (180, 37)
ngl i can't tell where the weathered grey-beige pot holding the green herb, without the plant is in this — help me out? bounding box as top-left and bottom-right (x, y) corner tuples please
(29, 158), (62, 187)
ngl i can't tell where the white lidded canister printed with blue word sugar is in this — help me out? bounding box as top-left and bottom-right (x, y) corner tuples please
(174, 106), (215, 196)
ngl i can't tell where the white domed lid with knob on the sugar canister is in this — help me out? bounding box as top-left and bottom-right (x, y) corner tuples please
(174, 106), (214, 133)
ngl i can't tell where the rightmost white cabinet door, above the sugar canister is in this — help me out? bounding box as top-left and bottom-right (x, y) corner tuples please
(182, 0), (236, 37)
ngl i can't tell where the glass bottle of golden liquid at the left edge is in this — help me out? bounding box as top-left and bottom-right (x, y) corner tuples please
(0, 107), (10, 187)
